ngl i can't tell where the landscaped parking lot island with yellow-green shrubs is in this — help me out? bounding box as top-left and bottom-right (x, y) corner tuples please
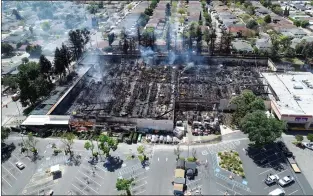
(218, 151), (245, 178)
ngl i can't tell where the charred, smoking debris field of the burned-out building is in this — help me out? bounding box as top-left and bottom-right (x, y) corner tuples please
(63, 58), (268, 120)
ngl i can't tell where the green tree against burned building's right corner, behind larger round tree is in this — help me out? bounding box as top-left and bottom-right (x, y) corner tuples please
(231, 90), (265, 125)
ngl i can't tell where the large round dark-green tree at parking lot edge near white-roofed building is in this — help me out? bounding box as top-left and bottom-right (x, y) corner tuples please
(240, 110), (286, 146)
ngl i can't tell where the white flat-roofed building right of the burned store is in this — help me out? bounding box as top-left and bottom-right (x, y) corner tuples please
(262, 72), (313, 130)
